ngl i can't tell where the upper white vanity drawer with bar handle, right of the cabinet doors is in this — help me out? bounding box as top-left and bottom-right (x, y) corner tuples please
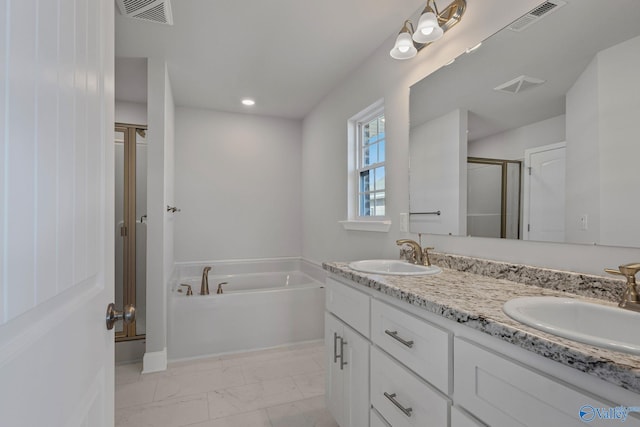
(371, 300), (452, 394)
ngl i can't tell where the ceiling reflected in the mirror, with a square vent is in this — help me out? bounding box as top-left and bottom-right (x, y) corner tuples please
(410, 0), (640, 141)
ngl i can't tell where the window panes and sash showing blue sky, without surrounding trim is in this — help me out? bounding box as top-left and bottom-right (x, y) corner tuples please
(357, 113), (385, 217)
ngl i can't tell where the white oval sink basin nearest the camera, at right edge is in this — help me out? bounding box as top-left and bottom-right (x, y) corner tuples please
(503, 297), (640, 355)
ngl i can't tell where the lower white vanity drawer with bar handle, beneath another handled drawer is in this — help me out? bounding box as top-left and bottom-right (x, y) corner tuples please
(371, 347), (450, 427)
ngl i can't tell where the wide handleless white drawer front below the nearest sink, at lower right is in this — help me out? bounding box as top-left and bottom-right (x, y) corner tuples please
(454, 338), (638, 427)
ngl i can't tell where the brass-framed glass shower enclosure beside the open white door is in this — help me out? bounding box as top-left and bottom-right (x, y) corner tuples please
(114, 123), (147, 341)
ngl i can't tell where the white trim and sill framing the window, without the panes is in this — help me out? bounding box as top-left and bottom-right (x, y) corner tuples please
(338, 99), (391, 233)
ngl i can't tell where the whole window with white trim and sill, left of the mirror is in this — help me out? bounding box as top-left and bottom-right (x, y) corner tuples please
(340, 100), (391, 232)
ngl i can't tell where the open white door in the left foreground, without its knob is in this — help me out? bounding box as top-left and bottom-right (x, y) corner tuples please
(0, 0), (114, 427)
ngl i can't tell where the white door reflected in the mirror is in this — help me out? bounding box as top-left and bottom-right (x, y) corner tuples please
(523, 142), (566, 242)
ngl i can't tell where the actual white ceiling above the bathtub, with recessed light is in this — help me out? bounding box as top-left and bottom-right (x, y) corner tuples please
(115, 0), (426, 119)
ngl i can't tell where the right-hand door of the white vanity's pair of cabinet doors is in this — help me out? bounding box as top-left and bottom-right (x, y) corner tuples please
(336, 326), (371, 427)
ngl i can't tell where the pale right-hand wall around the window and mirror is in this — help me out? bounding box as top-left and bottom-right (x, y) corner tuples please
(302, 0), (640, 273)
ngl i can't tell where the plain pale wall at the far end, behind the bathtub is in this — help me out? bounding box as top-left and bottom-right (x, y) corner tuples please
(175, 107), (304, 261)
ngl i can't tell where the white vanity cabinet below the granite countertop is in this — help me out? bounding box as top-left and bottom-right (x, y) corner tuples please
(325, 278), (640, 427)
